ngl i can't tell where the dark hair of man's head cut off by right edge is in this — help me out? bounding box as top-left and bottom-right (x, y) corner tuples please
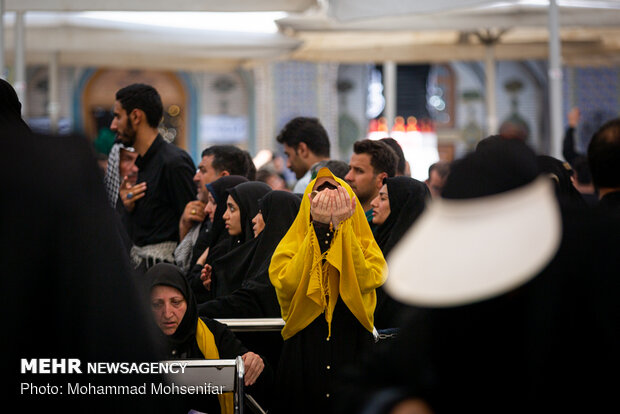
(588, 118), (620, 188)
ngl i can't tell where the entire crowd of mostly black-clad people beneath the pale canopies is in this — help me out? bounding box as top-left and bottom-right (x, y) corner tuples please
(1, 81), (620, 414)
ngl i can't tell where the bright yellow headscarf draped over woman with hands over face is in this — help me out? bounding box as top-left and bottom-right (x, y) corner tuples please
(269, 168), (387, 340)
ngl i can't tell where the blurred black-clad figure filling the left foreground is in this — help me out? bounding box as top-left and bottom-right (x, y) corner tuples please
(0, 97), (178, 413)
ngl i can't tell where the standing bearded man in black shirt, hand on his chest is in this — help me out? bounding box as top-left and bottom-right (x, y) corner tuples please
(110, 84), (196, 273)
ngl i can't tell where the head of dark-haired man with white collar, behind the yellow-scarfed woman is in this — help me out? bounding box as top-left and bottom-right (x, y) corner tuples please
(276, 117), (330, 193)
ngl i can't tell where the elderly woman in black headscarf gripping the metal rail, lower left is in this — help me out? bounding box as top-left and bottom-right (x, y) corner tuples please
(146, 263), (265, 414)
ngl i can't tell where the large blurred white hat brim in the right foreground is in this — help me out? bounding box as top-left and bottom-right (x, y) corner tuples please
(385, 177), (562, 307)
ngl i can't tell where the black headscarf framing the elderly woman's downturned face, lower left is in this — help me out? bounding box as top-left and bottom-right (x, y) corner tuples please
(145, 263), (198, 355)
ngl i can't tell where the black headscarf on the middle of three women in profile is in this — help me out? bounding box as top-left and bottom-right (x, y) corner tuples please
(209, 181), (271, 298)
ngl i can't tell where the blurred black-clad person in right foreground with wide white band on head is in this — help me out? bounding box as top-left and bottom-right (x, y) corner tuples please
(337, 139), (620, 414)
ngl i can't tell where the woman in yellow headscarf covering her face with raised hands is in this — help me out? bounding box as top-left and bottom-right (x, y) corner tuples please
(269, 168), (386, 413)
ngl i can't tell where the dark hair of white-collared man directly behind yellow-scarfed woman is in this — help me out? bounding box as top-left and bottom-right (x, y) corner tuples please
(276, 116), (329, 157)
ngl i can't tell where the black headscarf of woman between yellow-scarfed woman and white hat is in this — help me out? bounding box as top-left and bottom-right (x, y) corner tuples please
(375, 176), (430, 257)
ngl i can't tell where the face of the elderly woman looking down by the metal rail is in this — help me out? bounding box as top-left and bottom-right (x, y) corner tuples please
(151, 285), (187, 335)
